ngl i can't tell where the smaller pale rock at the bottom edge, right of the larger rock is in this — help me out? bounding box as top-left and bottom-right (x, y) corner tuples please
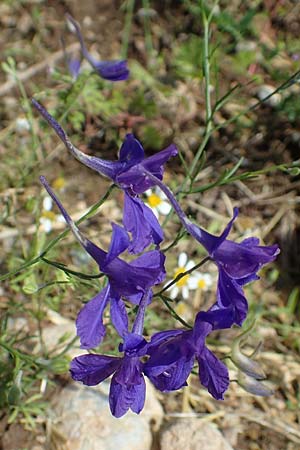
(160, 419), (233, 450)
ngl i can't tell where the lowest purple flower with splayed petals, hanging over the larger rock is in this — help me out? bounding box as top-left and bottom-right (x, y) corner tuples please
(70, 290), (151, 417)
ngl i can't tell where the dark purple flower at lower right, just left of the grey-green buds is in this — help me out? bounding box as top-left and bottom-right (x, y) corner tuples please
(144, 314), (229, 400)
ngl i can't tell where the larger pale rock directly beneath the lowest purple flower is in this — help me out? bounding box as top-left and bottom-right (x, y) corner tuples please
(50, 383), (163, 450)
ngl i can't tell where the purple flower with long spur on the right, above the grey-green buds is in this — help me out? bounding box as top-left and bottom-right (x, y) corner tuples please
(141, 169), (280, 328)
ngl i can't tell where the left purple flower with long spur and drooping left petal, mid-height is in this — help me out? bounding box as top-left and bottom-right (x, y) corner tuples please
(40, 177), (165, 348)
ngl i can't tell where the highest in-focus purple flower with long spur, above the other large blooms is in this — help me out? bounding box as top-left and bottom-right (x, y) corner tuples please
(32, 99), (177, 253)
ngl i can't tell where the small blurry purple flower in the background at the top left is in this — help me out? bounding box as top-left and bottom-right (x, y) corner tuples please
(66, 14), (129, 81)
